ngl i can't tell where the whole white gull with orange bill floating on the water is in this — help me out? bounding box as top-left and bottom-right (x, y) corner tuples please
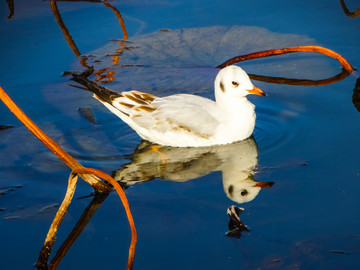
(74, 66), (265, 147)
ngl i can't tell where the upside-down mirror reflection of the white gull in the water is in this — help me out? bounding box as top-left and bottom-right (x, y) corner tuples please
(114, 138), (273, 203)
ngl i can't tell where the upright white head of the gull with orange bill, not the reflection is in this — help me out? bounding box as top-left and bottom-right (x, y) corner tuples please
(215, 66), (266, 98)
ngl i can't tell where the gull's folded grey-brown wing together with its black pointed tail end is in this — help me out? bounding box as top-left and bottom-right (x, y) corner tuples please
(73, 69), (219, 139)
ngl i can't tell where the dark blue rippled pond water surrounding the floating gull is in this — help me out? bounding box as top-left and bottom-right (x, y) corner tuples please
(0, 0), (360, 269)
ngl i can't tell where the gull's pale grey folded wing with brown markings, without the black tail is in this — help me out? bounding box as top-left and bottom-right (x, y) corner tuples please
(111, 91), (219, 137)
